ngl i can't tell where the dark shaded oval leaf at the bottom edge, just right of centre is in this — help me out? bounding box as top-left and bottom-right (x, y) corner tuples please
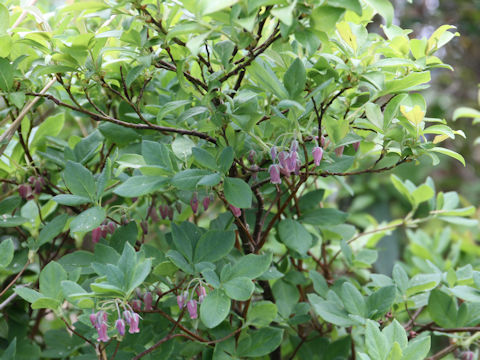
(237, 327), (283, 358)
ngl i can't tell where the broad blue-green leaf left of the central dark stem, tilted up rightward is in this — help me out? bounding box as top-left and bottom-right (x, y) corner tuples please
(193, 230), (235, 264)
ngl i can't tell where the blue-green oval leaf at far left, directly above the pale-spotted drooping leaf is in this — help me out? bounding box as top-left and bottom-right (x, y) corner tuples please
(63, 161), (96, 201)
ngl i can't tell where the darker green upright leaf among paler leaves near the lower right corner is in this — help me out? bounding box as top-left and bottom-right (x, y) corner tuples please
(428, 289), (458, 328)
